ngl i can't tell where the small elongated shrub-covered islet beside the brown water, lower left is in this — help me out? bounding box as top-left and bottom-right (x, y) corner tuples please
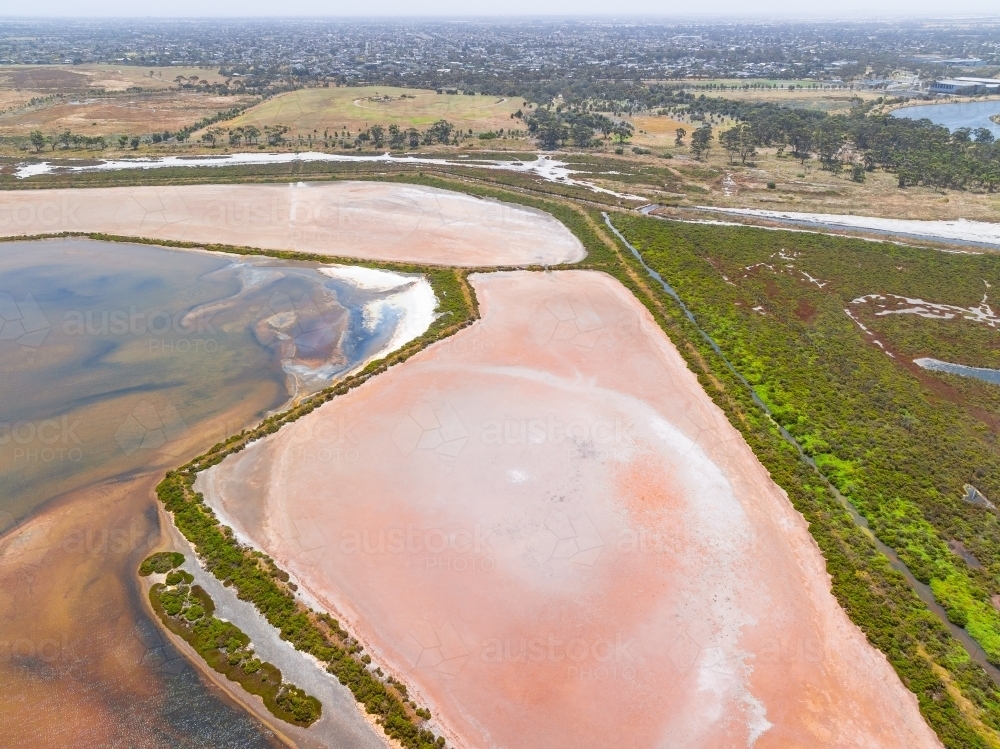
(139, 552), (323, 727)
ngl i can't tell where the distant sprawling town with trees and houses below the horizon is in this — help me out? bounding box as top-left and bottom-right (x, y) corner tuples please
(0, 19), (1000, 95)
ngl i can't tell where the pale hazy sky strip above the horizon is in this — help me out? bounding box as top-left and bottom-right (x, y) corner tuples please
(0, 0), (1000, 20)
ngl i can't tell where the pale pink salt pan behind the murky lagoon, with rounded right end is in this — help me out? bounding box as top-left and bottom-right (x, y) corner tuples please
(0, 182), (585, 266)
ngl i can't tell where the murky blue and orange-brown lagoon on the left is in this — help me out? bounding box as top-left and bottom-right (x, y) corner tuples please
(0, 239), (397, 747)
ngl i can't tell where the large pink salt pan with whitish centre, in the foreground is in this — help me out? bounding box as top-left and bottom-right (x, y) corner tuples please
(199, 271), (940, 749)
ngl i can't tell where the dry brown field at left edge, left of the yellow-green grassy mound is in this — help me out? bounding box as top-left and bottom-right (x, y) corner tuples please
(0, 90), (250, 136)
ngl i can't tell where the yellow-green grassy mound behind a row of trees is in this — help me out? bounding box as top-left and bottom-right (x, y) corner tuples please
(229, 86), (522, 135)
